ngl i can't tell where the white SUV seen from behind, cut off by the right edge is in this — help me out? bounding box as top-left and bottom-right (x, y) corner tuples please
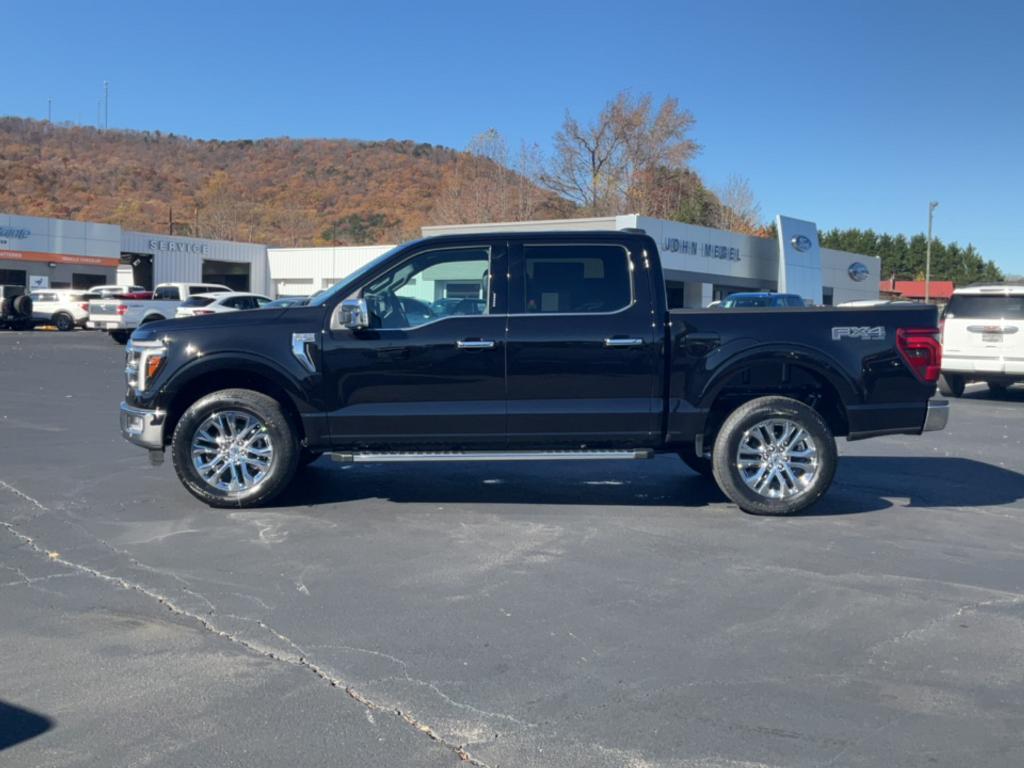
(939, 285), (1024, 397)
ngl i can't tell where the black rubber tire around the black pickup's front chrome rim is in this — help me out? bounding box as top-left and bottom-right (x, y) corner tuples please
(171, 389), (300, 508)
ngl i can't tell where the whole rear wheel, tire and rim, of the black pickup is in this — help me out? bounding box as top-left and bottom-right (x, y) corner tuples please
(713, 396), (838, 515)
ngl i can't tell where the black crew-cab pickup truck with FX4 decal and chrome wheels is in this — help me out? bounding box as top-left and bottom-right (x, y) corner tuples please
(121, 230), (948, 514)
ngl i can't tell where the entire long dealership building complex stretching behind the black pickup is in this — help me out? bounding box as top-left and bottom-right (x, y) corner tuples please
(0, 214), (881, 307)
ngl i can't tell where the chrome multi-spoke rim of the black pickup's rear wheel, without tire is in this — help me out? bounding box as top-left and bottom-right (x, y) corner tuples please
(736, 419), (818, 499)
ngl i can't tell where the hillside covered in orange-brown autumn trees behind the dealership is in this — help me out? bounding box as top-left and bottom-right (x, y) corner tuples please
(0, 118), (571, 246)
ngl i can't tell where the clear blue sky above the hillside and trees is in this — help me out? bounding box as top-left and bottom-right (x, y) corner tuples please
(6, 0), (1024, 272)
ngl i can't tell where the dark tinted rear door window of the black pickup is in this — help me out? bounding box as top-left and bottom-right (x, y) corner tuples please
(522, 244), (633, 314)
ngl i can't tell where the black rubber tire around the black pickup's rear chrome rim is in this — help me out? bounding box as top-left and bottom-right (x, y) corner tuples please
(712, 396), (839, 515)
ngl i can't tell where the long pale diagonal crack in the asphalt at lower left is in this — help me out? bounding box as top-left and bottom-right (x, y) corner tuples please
(0, 480), (490, 768)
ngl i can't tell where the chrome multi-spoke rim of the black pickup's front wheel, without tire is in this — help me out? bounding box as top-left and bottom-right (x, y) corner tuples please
(191, 411), (273, 493)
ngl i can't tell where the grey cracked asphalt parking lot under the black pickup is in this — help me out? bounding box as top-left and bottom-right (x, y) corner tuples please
(0, 332), (1024, 768)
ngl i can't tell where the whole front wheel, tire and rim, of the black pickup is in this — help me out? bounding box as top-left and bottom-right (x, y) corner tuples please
(171, 389), (299, 507)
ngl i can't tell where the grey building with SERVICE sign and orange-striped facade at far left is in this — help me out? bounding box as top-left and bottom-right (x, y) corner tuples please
(0, 213), (271, 293)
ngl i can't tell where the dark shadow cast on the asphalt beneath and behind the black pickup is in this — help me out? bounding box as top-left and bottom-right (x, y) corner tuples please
(273, 456), (1024, 516)
